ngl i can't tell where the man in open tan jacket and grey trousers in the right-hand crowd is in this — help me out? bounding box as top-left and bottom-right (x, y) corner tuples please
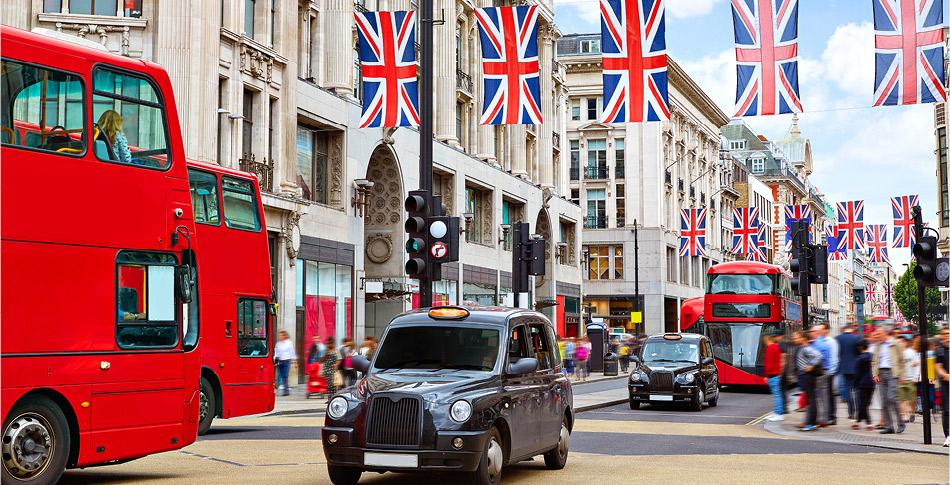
(871, 325), (905, 434)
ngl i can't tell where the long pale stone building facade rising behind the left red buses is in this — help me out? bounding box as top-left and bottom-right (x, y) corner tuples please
(0, 0), (583, 378)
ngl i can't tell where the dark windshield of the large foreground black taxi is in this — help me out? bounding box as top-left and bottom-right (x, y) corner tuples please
(373, 326), (500, 372)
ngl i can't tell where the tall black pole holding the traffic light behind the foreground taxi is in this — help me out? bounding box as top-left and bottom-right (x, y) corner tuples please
(419, 0), (435, 308)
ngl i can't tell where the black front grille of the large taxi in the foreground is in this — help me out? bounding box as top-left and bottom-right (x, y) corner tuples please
(366, 396), (422, 447)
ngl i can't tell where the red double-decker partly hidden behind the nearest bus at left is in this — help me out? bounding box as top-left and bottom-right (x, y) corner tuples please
(188, 160), (276, 435)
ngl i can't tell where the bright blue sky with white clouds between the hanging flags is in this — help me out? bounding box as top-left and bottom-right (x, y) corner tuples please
(554, 0), (948, 273)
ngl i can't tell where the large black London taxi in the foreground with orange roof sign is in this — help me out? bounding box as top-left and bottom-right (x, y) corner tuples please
(322, 306), (574, 485)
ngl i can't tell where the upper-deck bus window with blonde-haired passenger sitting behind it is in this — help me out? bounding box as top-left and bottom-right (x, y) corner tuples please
(92, 67), (171, 169)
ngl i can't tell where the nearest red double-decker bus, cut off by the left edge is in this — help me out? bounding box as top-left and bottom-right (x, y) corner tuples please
(0, 27), (201, 483)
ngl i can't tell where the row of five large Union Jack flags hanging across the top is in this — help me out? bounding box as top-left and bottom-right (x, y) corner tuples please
(355, 0), (947, 129)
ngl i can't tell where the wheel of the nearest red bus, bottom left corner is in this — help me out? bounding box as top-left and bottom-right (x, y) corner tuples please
(2, 395), (70, 483)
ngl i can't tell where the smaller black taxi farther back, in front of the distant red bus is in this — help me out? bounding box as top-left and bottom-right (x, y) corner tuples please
(627, 333), (719, 411)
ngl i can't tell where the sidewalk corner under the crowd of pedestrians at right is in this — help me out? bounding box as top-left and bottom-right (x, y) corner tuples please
(768, 394), (950, 455)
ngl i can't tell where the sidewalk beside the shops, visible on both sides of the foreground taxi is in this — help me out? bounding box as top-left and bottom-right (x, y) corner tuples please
(266, 374), (632, 416)
